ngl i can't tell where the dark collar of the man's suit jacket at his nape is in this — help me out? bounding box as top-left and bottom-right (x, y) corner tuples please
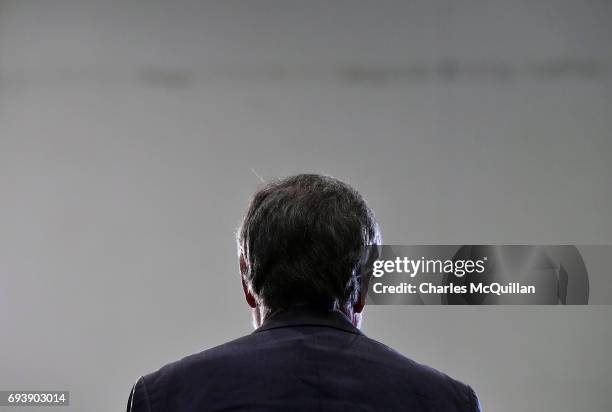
(253, 306), (363, 335)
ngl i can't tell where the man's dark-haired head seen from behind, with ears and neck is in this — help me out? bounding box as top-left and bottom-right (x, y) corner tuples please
(237, 174), (380, 327)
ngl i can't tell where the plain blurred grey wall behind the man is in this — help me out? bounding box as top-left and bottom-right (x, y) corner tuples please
(0, 0), (612, 412)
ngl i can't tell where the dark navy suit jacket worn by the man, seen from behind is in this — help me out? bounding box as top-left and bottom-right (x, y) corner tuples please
(127, 308), (480, 412)
